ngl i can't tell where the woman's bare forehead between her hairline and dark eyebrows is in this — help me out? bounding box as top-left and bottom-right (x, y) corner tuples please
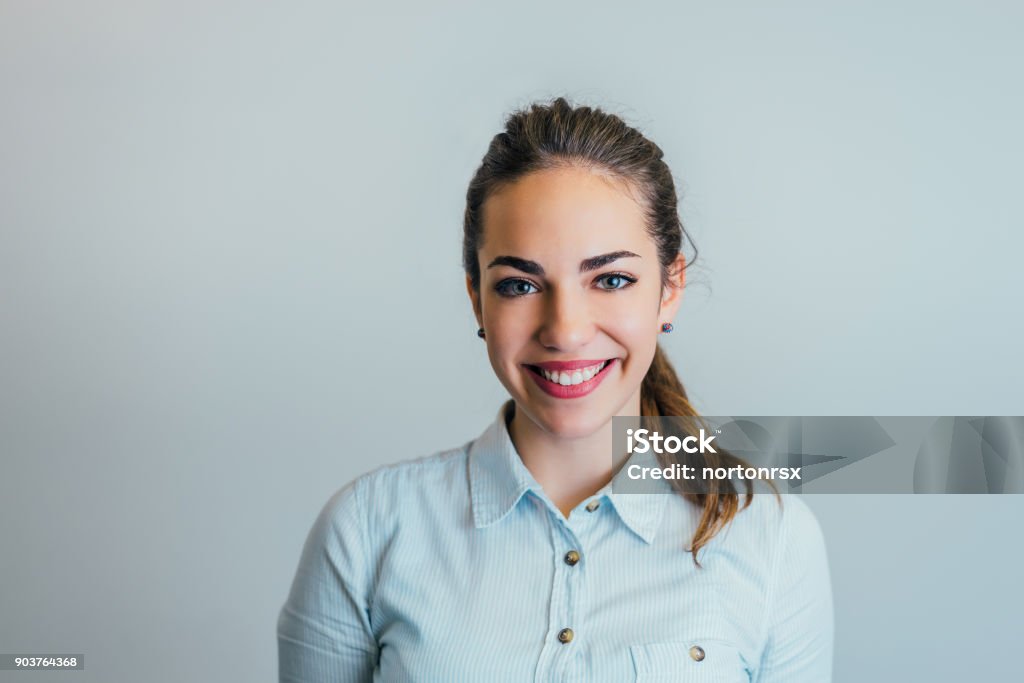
(481, 167), (653, 258)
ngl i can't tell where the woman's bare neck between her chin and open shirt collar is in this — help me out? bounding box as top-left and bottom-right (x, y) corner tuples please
(509, 389), (640, 518)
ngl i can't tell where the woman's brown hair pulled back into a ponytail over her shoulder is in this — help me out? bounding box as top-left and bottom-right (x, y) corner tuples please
(462, 97), (777, 566)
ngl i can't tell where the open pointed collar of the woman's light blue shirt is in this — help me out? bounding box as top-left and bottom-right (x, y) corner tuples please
(469, 399), (672, 544)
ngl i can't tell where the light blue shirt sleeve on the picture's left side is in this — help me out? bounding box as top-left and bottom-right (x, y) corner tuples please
(278, 479), (378, 683)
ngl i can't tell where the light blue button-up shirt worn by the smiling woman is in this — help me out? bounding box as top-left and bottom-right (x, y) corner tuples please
(278, 401), (834, 683)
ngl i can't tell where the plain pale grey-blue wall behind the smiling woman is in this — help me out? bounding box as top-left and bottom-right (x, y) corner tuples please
(0, 0), (1024, 683)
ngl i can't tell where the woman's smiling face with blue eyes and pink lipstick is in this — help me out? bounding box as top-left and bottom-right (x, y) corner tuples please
(467, 167), (683, 438)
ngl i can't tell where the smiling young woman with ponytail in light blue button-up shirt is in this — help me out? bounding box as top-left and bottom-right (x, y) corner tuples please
(278, 98), (834, 683)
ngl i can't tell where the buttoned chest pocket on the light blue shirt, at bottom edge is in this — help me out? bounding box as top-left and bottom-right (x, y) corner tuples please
(630, 638), (751, 683)
